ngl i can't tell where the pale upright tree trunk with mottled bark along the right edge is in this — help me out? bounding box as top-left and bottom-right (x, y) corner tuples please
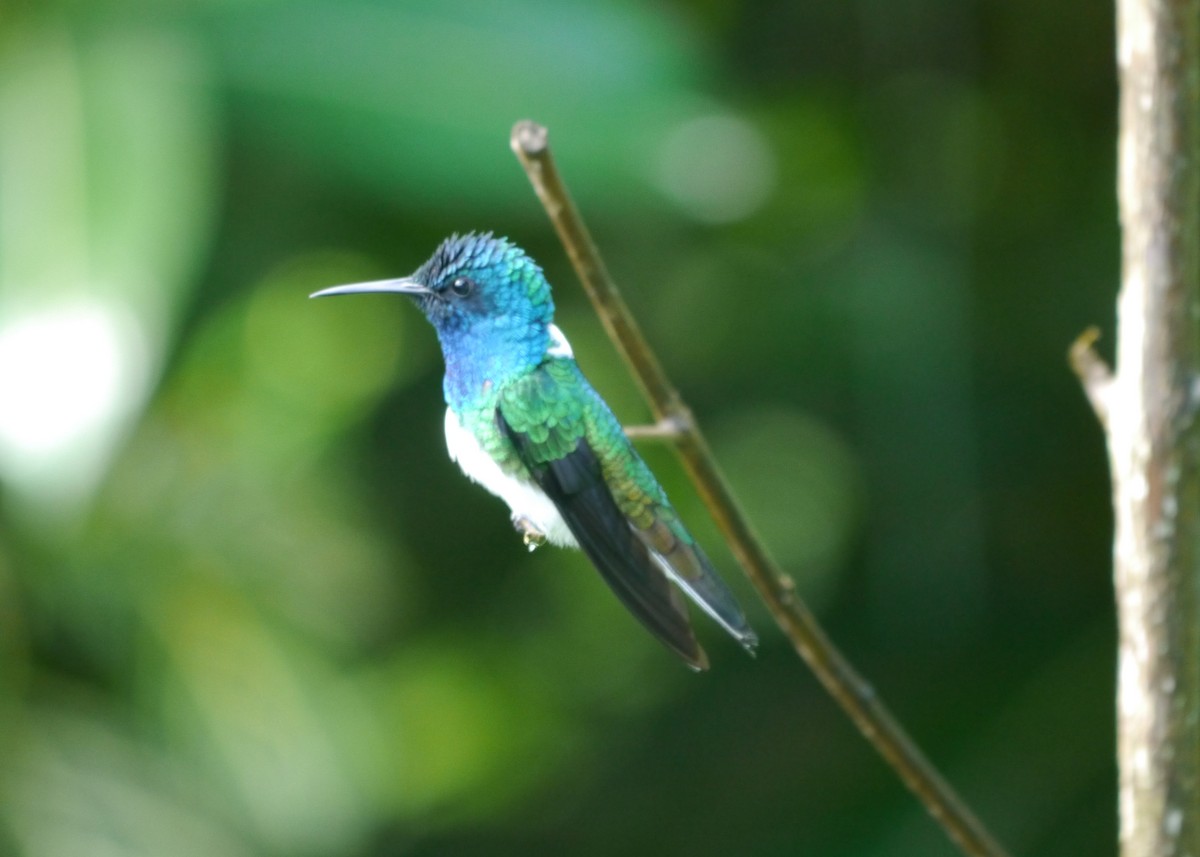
(1108, 0), (1200, 857)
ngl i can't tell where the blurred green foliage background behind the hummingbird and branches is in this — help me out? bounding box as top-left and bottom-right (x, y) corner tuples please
(0, 0), (1118, 857)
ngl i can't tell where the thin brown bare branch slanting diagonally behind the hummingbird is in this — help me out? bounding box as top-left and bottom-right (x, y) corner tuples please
(511, 121), (1004, 857)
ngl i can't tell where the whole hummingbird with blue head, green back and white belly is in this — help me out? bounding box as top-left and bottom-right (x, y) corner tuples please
(311, 233), (758, 671)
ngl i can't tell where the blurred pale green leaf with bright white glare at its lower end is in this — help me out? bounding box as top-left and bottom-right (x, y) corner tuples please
(0, 24), (215, 514)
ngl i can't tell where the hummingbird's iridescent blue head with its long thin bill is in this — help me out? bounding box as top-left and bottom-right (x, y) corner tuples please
(312, 233), (554, 362)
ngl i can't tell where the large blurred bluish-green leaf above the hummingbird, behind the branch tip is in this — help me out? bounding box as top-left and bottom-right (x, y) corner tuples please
(210, 0), (713, 212)
